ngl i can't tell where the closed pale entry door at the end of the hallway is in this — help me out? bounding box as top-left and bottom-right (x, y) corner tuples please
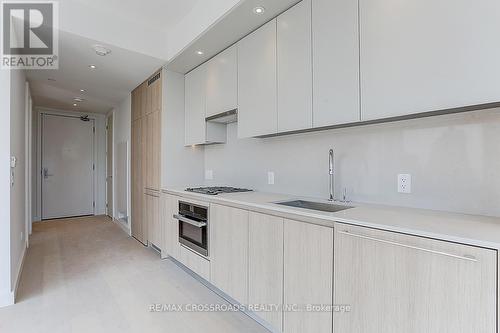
(41, 114), (94, 219)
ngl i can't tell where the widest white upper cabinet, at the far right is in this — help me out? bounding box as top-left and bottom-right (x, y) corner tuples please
(360, 0), (500, 120)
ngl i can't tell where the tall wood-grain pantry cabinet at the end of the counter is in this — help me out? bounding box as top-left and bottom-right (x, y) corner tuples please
(131, 70), (163, 249)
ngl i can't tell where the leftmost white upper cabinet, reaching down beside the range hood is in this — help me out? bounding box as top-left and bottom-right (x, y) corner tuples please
(184, 64), (226, 146)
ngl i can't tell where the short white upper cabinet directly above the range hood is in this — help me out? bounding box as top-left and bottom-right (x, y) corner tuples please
(206, 46), (238, 117)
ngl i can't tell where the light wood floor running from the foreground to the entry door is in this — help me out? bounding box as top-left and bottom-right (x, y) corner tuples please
(0, 217), (268, 333)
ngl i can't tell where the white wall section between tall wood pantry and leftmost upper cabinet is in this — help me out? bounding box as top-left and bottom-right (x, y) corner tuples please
(161, 69), (204, 188)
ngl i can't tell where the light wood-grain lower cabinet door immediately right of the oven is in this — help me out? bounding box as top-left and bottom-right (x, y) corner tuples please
(209, 204), (248, 304)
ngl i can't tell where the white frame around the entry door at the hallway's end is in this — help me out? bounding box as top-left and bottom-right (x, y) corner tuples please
(37, 109), (98, 221)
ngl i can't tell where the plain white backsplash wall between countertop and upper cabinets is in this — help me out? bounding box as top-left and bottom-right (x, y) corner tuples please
(205, 109), (500, 216)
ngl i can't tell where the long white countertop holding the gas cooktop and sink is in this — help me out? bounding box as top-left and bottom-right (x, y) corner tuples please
(163, 188), (500, 249)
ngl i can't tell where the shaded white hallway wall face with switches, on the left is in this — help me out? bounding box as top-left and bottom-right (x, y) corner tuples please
(10, 70), (26, 294)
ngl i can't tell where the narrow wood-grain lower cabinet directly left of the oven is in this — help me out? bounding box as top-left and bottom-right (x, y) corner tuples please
(160, 194), (180, 260)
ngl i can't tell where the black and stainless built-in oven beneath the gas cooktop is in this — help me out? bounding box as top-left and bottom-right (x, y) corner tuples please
(174, 201), (208, 257)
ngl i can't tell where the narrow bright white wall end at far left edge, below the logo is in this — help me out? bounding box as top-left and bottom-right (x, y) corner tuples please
(0, 70), (14, 307)
